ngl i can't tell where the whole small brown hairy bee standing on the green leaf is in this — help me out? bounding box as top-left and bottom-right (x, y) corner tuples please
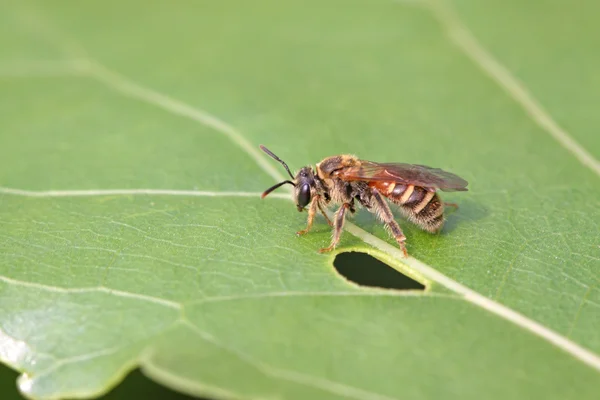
(260, 145), (468, 257)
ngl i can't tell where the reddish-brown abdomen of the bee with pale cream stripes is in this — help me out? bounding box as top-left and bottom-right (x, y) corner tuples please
(369, 182), (444, 233)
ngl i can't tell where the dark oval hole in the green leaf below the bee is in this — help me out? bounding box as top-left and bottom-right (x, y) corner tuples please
(333, 251), (425, 290)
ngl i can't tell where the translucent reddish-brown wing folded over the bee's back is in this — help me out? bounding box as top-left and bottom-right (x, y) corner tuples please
(337, 160), (468, 192)
